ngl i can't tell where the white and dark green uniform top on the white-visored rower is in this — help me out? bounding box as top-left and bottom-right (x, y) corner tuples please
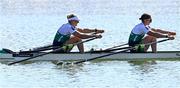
(53, 23), (76, 52)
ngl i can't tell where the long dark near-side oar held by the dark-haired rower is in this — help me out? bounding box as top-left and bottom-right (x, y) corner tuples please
(69, 39), (170, 64)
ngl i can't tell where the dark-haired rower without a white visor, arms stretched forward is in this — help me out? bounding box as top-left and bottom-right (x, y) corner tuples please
(128, 13), (176, 53)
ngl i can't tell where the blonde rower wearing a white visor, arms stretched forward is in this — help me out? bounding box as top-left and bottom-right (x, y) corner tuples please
(53, 14), (104, 53)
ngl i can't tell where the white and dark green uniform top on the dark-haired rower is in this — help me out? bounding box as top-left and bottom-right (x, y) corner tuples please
(128, 23), (151, 52)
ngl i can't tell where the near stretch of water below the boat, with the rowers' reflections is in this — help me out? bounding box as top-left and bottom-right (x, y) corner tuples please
(0, 61), (180, 88)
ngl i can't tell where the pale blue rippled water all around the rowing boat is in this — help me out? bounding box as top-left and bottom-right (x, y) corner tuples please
(0, 0), (180, 88)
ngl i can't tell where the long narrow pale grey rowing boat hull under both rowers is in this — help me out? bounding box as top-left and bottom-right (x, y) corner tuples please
(0, 51), (180, 62)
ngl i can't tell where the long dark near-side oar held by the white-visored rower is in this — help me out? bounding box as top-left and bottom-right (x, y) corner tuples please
(8, 37), (97, 65)
